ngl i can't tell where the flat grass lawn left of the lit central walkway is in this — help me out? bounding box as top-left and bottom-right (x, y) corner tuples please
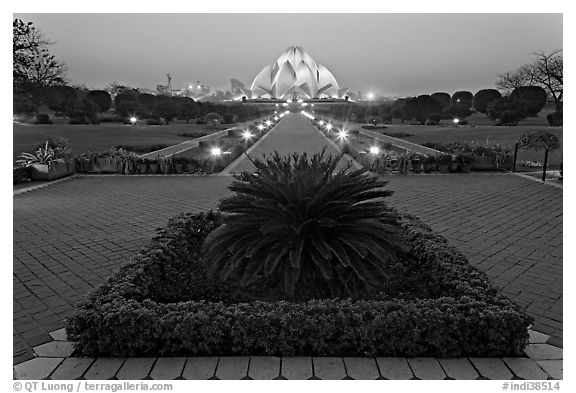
(12, 122), (228, 161)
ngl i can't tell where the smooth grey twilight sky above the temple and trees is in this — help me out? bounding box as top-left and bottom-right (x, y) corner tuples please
(14, 14), (563, 96)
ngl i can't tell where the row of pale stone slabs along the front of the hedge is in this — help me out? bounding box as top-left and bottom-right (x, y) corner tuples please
(14, 329), (563, 380)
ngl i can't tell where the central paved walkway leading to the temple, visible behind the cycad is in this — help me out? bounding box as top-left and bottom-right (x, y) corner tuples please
(227, 113), (338, 173)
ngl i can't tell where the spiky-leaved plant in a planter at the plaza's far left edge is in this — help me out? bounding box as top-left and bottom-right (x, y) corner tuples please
(16, 142), (73, 181)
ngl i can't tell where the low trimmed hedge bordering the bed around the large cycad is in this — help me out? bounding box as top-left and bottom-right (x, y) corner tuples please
(66, 213), (532, 357)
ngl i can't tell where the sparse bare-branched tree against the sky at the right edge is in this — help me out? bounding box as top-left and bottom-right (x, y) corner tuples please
(496, 50), (564, 112)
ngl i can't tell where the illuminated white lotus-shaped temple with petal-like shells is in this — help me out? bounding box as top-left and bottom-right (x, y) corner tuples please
(243, 46), (348, 101)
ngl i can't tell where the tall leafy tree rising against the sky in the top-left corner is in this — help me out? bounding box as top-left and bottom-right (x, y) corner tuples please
(12, 19), (66, 90)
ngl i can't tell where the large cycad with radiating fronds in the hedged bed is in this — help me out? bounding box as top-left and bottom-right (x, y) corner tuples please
(203, 151), (407, 299)
